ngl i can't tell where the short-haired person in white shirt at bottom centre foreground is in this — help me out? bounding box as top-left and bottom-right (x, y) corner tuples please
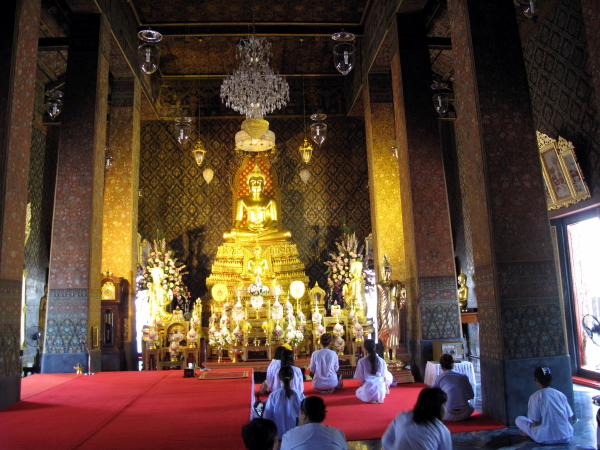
(281, 397), (348, 450)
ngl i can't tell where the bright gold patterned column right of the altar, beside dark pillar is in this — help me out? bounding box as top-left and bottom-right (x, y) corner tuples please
(364, 89), (406, 280)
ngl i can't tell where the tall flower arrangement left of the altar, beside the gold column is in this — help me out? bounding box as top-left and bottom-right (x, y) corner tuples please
(137, 239), (191, 304)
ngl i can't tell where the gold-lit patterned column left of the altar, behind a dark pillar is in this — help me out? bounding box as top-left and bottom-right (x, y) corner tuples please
(102, 78), (141, 370)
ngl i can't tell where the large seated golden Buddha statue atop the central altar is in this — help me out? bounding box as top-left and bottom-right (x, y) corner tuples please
(223, 164), (292, 242)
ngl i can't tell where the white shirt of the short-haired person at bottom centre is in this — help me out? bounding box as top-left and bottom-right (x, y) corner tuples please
(281, 423), (348, 450)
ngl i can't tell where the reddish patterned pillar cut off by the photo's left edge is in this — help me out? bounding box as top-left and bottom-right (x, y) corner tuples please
(0, 0), (40, 408)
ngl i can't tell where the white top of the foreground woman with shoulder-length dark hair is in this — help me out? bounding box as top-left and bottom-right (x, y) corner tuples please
(381, 411), (452, 450)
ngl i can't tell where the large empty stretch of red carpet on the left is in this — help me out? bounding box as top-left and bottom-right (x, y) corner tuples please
(0, 369), (254, 450)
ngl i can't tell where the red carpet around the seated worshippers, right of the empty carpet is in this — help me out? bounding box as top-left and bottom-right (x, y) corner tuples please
(296, 380), (506, 441)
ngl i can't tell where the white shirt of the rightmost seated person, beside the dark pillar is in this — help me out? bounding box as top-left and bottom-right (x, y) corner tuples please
(527, 388), (573, 443)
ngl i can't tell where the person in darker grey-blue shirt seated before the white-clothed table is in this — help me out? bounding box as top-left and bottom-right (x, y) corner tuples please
(431, 354), (475, 422)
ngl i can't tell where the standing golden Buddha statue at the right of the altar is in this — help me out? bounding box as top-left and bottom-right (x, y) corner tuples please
(376, 255), (406, 362)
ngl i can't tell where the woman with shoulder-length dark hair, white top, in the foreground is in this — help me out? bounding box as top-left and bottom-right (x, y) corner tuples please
(381, 388), (452, 450)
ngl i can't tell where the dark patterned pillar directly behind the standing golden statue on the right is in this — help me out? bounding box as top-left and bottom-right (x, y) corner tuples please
(391, 13), (462, 379)
